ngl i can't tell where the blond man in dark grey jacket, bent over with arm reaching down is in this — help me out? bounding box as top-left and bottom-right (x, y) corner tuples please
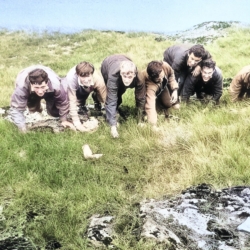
(101, 55), (146, 138)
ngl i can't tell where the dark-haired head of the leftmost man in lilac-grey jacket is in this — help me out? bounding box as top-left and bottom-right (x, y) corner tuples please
(28, 69), (49, 96)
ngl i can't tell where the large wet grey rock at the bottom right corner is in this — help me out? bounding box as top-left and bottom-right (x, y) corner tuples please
(140, 184), (250, 250)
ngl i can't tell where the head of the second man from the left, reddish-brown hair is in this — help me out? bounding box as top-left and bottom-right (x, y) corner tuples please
(76, 61), (95, 88)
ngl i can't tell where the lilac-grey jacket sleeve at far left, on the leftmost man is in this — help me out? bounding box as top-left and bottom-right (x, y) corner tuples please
(10, 87), (28, 129)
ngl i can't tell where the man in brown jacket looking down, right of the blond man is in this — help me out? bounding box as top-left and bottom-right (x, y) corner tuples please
(143, 61), (179, 125)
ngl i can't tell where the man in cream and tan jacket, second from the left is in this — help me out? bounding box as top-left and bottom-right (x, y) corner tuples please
(62, 61), (107, 132)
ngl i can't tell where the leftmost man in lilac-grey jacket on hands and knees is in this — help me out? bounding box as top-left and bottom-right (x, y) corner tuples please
(10, 65), (75, 132)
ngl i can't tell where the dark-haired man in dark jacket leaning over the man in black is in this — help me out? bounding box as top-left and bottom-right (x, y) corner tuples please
(163, 44), (211, 101)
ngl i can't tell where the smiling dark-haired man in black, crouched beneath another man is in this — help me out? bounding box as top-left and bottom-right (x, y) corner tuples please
(186, 59), (223, 104)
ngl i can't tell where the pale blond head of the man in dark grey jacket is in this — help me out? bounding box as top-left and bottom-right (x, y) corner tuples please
(120, 61), (136, 86)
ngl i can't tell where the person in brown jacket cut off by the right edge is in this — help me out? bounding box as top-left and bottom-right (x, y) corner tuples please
(229, 65), (250, 102)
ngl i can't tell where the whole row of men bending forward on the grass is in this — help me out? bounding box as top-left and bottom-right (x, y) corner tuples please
(10, 44), (250, 138)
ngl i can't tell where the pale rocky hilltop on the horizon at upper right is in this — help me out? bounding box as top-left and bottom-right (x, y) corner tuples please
(155, 21), (250, 44)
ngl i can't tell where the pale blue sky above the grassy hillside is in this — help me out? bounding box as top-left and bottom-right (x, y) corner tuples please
(0, 0), (250, 33)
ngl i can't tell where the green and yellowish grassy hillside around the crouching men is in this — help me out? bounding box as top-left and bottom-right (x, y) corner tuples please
(0, 29), (250, 250)
